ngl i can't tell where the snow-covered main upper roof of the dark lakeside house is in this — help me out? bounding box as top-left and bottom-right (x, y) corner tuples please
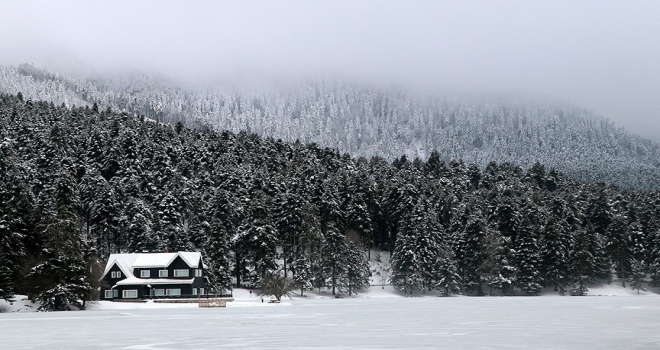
(101, 252), (202, 278)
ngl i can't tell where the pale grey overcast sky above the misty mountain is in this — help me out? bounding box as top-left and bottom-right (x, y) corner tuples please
(0, 0), (660, 140)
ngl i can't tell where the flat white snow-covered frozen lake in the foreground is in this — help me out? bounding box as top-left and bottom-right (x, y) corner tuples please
(0, 297), (660, 349)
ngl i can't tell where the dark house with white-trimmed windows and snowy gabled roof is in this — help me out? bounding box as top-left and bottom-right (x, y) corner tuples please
(100, 252), (207, 300)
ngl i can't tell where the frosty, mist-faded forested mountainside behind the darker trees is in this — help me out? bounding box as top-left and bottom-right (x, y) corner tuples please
(0, 64), (660, 189)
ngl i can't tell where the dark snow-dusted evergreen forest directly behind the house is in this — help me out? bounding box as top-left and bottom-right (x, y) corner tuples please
(0, 94), (660, 309)
